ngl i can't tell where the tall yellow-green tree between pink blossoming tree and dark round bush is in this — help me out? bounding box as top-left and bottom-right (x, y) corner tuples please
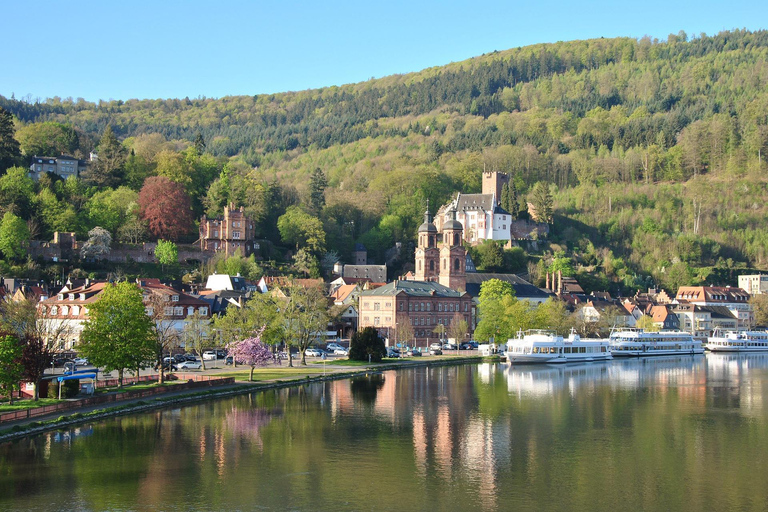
(280, 283), (328, 366)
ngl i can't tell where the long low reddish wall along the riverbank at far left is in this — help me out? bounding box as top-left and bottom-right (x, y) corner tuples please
(0, 374), (235, 423)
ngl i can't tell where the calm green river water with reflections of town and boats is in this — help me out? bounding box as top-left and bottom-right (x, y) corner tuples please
(0, 354), (768, 511)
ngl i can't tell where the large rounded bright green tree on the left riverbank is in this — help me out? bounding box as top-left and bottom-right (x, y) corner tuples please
(80, 282), (156, 387)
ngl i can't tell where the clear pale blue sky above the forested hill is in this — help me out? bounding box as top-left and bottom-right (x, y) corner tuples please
(0, 0), (768, 101)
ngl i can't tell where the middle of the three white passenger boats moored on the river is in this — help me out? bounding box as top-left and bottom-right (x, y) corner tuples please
(609, 329), (704, 357)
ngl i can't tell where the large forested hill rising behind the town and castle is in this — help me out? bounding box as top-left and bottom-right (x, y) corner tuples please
(0, 31), (768, 294)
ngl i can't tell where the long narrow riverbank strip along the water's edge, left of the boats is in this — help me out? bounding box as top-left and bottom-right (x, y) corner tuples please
(0, 356), (498, 442)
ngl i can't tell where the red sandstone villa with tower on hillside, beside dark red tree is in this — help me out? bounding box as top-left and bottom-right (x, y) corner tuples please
(200, 204), (256, 256)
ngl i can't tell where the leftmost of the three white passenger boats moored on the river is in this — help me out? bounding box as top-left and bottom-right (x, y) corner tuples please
(507, 329), (611, 364)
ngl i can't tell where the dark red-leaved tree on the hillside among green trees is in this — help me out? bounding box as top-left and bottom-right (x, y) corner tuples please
(139, 176), (192, 241)
